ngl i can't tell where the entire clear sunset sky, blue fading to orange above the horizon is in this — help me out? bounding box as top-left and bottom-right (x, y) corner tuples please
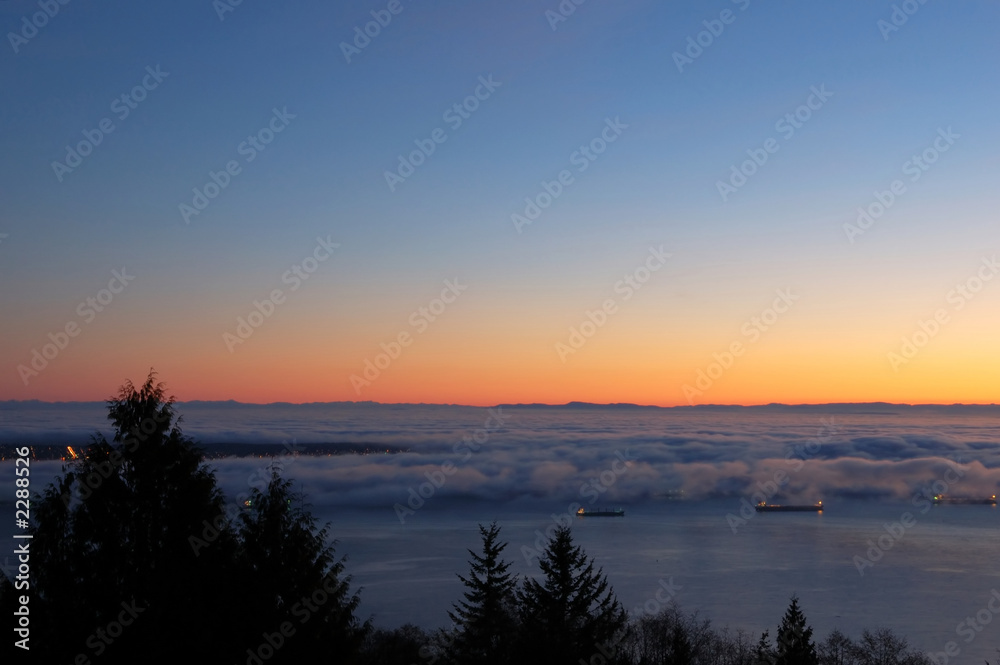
(0, 0), (1000, 406)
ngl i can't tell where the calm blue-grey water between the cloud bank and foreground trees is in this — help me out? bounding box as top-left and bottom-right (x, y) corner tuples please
(319, 500), (1000, 663)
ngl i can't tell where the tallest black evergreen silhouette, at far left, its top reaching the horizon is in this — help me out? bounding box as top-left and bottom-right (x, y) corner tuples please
(32, 372), (239, 663)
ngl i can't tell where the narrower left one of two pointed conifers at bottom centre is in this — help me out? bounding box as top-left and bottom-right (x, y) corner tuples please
(447, 522), (517, 665)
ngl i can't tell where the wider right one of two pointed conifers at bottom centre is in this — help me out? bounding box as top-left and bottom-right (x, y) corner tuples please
(518, 527), (628, 665)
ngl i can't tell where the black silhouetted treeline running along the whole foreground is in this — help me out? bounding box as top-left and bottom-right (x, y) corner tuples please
(0, 374), (992, 665)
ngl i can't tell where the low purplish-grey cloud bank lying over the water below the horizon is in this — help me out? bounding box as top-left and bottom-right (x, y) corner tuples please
(0, 403), (1000, 508)
